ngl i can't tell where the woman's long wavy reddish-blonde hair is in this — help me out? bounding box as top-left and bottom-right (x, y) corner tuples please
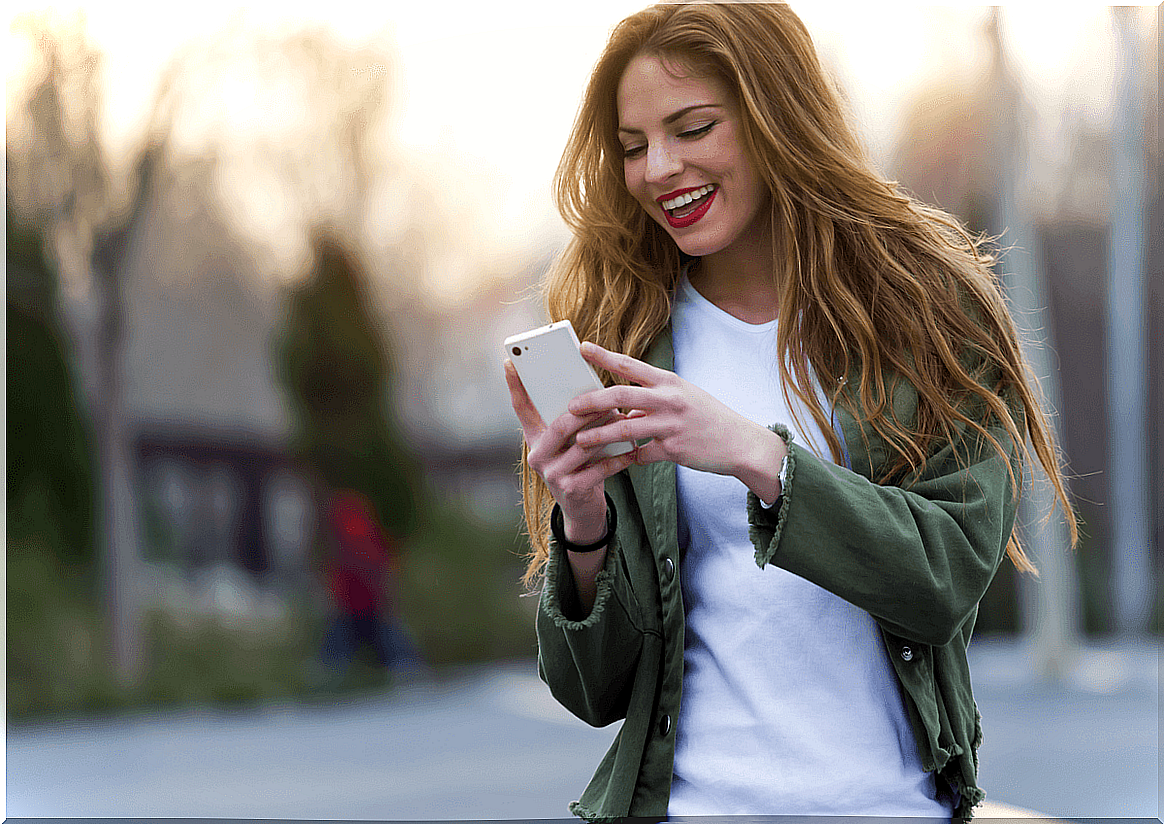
(521, 2), (1078, 587)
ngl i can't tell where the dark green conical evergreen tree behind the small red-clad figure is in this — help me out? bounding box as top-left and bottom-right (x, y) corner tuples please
(277, 232), (420, 537)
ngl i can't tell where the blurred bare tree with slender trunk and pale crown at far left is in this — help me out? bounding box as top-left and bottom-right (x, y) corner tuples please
(6, 13), (150, 683)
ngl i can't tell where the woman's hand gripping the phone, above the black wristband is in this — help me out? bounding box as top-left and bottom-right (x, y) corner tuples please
(505, 358), (634, 544)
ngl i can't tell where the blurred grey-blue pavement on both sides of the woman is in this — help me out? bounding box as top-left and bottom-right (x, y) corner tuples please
(6, 644), (1159, 821)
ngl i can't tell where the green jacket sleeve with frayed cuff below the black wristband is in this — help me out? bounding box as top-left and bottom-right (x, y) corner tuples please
(537, 521), (644, 726)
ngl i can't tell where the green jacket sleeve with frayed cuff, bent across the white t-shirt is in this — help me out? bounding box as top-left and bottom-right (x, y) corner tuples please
(747, 412), (1022, 646)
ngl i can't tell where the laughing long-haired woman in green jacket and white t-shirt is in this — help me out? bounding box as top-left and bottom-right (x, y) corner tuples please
(506, 3), (1074, 819)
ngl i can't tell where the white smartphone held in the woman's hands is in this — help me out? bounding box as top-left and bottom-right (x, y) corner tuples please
(504, 320), (634, 455)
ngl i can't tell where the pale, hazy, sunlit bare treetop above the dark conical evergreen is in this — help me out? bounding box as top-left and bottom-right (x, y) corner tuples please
(140, 15), (407, 293)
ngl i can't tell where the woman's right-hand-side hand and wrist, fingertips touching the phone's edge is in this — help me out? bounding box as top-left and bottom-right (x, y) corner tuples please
(569, 342), (788, 504)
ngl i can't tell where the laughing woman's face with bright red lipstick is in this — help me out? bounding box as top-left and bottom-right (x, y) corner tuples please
(617, 55), (768, 257)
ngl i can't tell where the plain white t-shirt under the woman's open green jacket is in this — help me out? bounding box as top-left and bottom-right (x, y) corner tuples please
(668, 276), (952, 821)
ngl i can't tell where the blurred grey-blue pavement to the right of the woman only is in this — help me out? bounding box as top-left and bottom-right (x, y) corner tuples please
(971, 639), (1161, 819)
